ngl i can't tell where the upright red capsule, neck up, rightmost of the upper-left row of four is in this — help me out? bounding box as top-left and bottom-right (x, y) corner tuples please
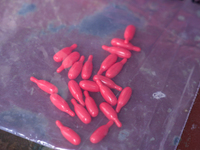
(81, 55), (93, 80)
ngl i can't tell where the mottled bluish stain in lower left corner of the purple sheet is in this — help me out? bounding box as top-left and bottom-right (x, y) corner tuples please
(0, 106), (48, 137)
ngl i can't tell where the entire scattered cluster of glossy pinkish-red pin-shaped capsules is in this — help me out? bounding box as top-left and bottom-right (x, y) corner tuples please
(30, 25), (140, 145)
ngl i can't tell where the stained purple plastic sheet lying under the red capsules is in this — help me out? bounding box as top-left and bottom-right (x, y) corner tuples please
(0, 0), (200, 150)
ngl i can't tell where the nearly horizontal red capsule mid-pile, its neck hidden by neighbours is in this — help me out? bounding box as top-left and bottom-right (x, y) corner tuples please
(79, 80), (99, 92)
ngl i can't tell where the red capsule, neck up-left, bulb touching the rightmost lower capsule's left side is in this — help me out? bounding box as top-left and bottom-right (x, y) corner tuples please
(96, 79), (117, 106)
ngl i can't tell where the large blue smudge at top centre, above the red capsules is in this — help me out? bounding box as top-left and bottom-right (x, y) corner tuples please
(78, 4), (144, 37)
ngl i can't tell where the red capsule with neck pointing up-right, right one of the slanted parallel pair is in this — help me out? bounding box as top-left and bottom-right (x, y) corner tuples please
(106, 58), (127, 78)
